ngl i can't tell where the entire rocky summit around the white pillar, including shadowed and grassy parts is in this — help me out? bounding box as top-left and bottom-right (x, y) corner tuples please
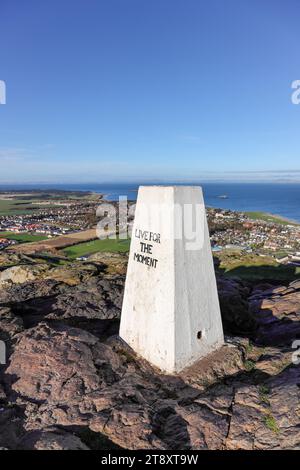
(0, 254), (300, 450)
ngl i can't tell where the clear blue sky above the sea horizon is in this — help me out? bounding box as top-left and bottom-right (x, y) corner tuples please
(0, 0), (300, 183)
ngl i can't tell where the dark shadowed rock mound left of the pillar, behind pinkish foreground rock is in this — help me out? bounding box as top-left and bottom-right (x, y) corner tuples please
(0, 276), (124, 337)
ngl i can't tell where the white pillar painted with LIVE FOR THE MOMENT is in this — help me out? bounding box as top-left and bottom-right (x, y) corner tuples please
(120, 186), (224, 374)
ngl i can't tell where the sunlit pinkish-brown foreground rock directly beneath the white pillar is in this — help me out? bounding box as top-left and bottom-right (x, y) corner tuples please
(5, 324), (300, 450)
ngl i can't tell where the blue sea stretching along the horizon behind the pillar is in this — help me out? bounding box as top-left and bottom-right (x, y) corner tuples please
(0, 181), (300, 222)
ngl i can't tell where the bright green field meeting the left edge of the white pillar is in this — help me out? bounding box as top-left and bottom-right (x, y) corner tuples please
(62, 239), (130, 259)
